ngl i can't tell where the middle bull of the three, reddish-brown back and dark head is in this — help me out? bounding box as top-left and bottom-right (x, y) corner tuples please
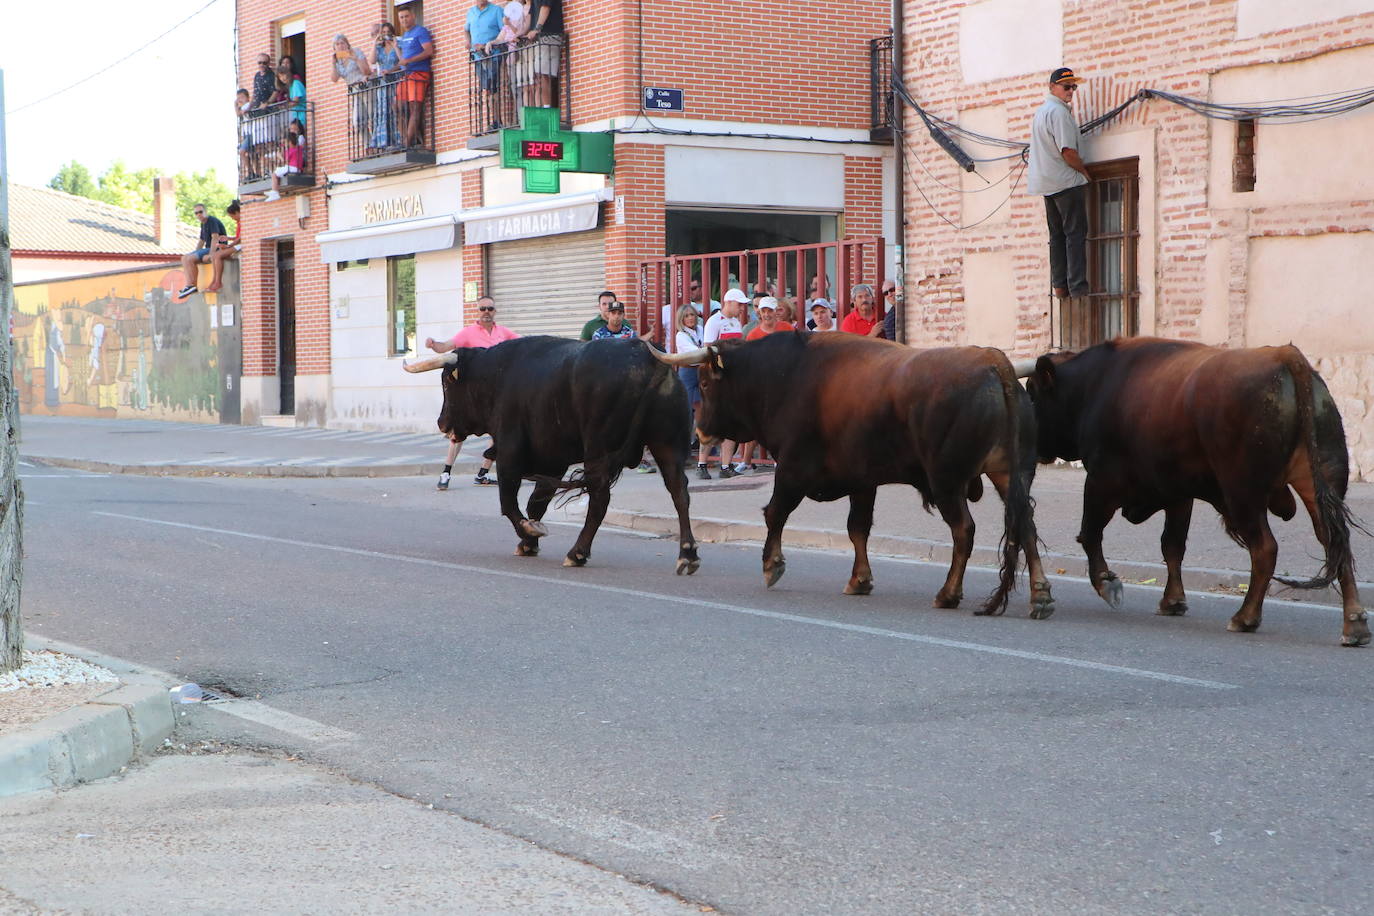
(655, 331), (1054, 618)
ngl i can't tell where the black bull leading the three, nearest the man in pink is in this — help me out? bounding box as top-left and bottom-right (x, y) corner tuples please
(405, 336), (699, 575)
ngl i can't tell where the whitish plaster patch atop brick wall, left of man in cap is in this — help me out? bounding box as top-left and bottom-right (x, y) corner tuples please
(959, 0), (1072, 82)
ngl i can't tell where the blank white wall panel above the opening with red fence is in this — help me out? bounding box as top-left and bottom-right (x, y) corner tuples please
(664, 146), (845, 210)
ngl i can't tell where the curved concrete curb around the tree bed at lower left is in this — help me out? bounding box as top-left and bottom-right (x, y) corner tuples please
(0, 674), (173, 798)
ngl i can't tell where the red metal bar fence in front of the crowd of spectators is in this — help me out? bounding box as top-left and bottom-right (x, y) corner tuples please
(635, 236), (886, 349)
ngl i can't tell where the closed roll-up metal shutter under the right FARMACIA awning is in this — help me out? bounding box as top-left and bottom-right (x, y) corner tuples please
(485, 229), (606, 339)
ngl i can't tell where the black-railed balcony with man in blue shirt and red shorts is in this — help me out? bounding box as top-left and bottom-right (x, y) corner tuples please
(346, 73), (434, 174)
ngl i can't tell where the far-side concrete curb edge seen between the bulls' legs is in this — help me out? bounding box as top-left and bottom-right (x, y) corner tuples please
(602, 508), (1352, 607)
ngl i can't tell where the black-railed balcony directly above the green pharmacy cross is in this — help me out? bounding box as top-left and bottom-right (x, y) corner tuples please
(467, 36), (573, 150)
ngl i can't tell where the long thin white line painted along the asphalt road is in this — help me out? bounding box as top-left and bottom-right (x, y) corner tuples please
(92, 511), (1239, 691)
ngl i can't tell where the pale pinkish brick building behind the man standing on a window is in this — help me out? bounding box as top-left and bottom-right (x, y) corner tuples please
(903, 0), (1374, 479)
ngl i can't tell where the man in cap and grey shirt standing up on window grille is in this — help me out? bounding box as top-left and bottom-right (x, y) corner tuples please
(1026, 67), (1088, 307)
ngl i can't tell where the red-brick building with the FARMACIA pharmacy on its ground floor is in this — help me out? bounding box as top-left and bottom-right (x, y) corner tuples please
(230, 0), (896, 428)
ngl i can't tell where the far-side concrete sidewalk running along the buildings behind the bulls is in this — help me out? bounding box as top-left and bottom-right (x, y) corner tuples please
(19, 416), (1374, 603)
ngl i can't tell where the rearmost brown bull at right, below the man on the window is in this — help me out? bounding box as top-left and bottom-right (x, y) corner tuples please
(1028, 338), (1370, 645)
